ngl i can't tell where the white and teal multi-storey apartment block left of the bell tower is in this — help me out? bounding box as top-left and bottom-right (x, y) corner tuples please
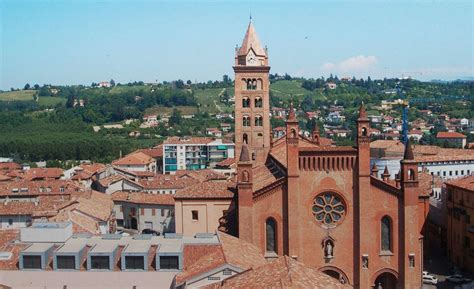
(163, 137), (235, 174)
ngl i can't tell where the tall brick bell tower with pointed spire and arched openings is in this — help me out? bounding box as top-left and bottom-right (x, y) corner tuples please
(233, 19), (270, 155)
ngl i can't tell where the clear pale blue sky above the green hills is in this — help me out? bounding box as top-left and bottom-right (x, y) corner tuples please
(0, 0), (474, 90)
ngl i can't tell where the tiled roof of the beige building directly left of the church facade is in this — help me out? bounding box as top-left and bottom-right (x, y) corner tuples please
(174, 181), (235, 199)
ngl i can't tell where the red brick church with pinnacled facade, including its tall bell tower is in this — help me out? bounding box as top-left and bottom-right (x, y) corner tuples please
(224, 22), (429, 289)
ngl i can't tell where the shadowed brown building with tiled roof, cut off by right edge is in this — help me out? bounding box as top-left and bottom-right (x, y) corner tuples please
(446, 176), (474, 272)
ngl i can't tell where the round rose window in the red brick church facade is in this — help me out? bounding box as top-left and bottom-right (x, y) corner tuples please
(312, 192), (346, 226)
